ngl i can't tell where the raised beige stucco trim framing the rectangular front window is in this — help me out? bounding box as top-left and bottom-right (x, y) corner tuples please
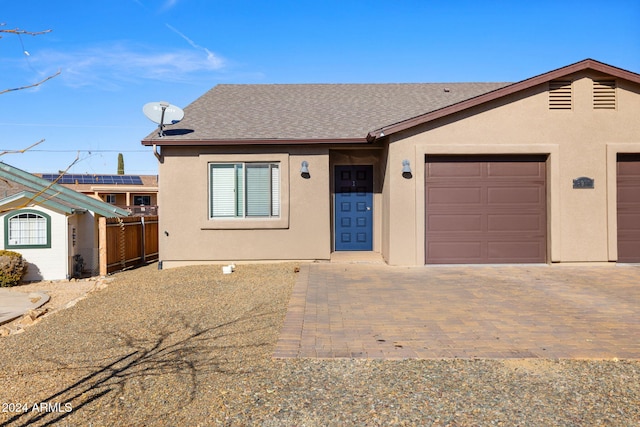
(199, 153), (290, 230)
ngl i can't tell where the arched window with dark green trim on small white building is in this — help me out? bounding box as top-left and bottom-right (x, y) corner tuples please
(4, 210), (51, 249)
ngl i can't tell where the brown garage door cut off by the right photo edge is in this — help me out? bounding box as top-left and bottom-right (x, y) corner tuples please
(617, 154), (640, 262)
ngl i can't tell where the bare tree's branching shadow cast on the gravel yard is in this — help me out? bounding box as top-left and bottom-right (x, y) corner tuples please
(2, 307), (277, 427)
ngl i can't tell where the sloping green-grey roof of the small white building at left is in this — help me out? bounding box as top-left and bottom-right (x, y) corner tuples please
(0, 162), (129, 217)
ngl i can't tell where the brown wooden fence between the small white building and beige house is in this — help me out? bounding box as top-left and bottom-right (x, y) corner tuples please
(99, 216), (158, 276)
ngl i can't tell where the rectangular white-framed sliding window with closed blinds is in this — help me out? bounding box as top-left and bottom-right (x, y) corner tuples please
(209, 163), (280, 218)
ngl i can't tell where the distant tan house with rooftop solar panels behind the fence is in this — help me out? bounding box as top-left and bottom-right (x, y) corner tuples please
(35, 174), (158, 216)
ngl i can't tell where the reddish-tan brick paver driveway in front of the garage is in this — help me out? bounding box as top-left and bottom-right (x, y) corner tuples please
(274, 263), (640, 359)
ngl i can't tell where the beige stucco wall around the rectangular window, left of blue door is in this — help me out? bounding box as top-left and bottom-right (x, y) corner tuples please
(158, 147), (331, 267)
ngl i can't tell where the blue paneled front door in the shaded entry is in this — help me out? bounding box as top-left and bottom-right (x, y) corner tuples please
(334, 165), (373, 251)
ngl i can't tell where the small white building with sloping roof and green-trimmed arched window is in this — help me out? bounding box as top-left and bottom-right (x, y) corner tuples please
(0, 162), (129, 281)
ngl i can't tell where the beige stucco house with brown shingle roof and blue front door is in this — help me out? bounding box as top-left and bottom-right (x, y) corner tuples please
(142, 59), (640, 267)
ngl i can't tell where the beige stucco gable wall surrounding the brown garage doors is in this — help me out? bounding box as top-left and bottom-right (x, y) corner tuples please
(382, 73), (640, 265)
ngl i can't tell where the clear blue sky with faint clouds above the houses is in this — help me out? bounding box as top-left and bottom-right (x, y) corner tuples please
(0, 0), (640, 174)
